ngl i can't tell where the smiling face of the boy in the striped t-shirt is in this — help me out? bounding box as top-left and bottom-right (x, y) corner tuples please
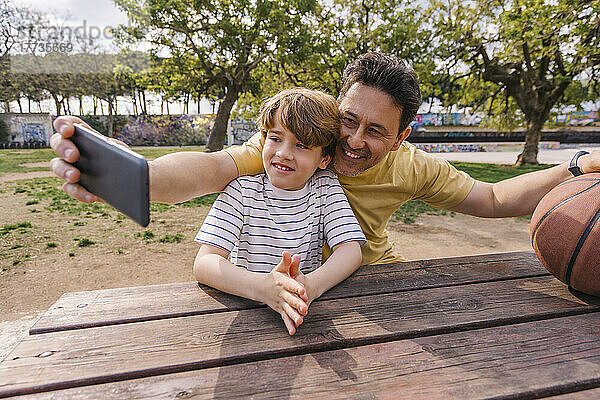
(262, 111), (331, 190)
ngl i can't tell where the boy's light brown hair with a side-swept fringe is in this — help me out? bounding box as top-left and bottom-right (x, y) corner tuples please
(257, 88), (340, 156)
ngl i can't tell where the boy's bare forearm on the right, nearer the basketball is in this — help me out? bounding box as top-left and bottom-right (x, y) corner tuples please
(306, 241), (362, 302)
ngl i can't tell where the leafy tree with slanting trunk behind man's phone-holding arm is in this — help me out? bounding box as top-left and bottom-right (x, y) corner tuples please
(115, 0), (317, 151)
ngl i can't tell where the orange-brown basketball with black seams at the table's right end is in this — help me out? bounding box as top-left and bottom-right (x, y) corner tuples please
(530, 173), (600, 296)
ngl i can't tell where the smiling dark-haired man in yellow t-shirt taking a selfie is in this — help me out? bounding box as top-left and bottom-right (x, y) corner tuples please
(50, 53), (600, 264)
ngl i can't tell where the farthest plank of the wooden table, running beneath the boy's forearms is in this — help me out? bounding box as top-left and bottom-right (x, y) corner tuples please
(30, 252), (549, 334)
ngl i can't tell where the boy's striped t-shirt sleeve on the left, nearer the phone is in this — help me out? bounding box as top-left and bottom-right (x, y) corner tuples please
(194, 179), (244, 253)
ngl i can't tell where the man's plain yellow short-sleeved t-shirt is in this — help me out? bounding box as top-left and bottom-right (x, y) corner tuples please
(226, 133), (475, 265)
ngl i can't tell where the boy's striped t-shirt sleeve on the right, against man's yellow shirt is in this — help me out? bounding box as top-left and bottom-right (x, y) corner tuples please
(324, 174), (367, 249)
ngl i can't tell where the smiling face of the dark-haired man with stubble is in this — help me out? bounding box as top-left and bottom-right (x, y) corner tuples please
(333, 83), (410, 176)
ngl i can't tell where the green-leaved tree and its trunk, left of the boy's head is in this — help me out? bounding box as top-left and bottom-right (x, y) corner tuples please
(115, 0), (328, 150)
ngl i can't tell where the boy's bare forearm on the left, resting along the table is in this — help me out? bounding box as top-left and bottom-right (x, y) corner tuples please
(194, 254), (265, 303)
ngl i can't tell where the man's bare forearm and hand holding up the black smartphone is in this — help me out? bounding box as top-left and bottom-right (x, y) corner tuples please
(50, 116), (238, 203)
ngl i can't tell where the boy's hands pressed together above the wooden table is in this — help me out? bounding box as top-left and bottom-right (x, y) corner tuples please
(264, 251), (314, 335)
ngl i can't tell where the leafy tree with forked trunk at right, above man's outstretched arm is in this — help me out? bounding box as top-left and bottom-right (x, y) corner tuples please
(432, 0), (600, 165)
